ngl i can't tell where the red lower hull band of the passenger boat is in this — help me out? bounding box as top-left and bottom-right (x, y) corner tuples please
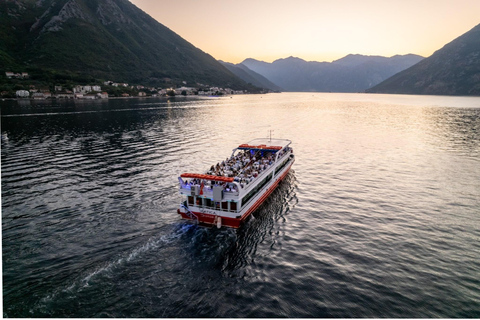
(177, 162), (293, 229)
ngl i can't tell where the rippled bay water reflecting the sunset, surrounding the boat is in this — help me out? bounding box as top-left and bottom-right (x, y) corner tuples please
(0, 94), (480, 318)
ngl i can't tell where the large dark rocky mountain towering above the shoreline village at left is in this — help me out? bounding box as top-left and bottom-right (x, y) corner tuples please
(0, 0), (255, 89)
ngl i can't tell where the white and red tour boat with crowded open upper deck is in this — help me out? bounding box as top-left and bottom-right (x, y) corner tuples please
(177, 138), (295, 228)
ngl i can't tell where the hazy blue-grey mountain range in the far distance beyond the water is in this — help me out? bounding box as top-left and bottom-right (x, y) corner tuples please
(242, 54), (423, 92)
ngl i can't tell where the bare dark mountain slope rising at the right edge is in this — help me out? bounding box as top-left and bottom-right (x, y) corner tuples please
(367, 25), (480, 95)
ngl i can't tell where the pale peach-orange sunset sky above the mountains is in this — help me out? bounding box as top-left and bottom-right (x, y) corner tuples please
(131, 0), (480, 63)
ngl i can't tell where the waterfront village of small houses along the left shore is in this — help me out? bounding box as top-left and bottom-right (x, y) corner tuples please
(0, 72), (251, 100)
